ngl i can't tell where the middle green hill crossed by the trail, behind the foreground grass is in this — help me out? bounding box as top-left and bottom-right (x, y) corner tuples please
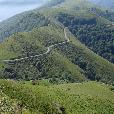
(0, 24), (114, 83)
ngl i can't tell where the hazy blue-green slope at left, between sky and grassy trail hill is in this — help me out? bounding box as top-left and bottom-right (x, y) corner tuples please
(0, 11), (49, 41)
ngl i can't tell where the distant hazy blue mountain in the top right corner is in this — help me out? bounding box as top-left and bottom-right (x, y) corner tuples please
(89, 0), (114, 10)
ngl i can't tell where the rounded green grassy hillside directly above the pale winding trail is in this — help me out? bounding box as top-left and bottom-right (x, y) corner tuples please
(0, 26), (64, 60)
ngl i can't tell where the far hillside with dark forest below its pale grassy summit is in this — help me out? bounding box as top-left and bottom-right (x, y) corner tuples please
(40, 0), (114, 63)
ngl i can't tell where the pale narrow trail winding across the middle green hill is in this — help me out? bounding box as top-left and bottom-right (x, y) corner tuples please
(2, 28), (70, 62)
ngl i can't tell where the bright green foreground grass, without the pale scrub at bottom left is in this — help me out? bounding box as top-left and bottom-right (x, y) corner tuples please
(0, 80), (114, 114)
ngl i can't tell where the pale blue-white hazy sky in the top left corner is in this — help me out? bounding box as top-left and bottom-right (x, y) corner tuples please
(0, 0), (47, 21)
